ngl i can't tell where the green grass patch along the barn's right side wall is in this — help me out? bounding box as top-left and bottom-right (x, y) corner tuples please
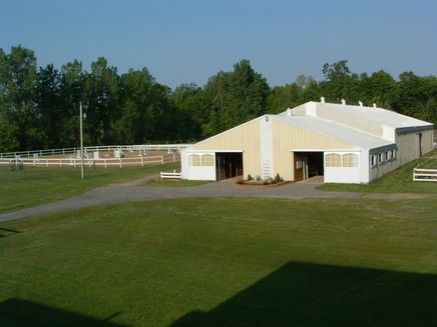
(317, 151), (437, 194)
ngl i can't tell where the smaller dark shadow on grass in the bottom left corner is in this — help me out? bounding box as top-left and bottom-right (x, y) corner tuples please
(0, 298), (123, 327)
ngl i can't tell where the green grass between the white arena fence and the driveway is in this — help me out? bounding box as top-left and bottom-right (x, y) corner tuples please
(0, 164), (179, 212)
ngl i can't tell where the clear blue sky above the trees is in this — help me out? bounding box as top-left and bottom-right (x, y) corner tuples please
(0, 0), (437, 87)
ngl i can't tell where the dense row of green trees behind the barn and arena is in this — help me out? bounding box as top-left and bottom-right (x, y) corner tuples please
(0, 46), (437, 152)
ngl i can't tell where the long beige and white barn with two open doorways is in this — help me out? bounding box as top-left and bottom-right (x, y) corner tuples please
(181, 98), (433, 183)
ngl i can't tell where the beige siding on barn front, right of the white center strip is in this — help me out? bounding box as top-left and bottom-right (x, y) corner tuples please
(273, 120), (353, 181)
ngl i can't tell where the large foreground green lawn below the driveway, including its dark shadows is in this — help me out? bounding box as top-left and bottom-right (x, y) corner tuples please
(0, 198), (437, 326)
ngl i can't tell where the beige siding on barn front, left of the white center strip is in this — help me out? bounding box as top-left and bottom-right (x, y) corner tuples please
(193, 118), (261, 176)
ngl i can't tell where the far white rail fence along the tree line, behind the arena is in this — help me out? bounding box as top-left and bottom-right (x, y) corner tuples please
(0, 143), (191, 158)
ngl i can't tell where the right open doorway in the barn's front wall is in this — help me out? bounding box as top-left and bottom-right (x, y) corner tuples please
(294, 151), (324, 183)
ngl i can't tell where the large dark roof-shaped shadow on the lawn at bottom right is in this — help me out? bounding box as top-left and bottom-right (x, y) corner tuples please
(173, 262), (437, 327)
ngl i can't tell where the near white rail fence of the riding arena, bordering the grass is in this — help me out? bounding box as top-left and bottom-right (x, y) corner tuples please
(0, 152), (180, 168)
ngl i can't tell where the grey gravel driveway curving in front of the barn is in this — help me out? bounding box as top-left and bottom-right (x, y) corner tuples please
(0, 176), (361, 222)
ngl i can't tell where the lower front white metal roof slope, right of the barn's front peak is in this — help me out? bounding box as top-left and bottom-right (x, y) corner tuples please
(272, 114), (394, 149)
